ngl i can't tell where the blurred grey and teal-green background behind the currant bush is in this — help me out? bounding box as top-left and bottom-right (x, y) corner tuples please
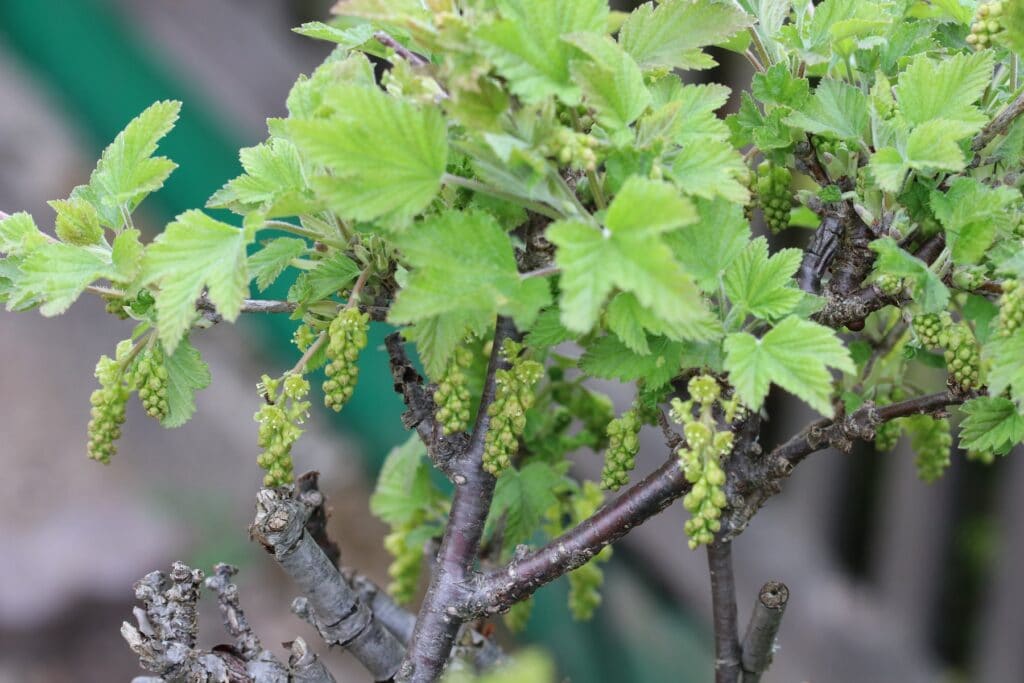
(0, 0), (1024, 683)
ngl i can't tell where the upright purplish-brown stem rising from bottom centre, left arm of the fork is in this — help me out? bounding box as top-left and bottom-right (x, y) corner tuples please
(395, 316), (515, 683)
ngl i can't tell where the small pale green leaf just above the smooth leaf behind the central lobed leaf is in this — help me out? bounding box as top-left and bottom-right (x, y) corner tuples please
(669, 140), (751, 204)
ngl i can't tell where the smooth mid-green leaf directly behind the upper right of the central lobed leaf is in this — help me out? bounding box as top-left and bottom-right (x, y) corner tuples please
(666, 198), (751, 293)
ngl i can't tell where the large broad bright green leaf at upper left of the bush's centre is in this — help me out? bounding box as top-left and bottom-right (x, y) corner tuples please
(287, 86), (447, 222)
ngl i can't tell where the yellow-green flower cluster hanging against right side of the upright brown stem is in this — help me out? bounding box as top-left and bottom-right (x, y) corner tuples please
(483, 340), (544, 476)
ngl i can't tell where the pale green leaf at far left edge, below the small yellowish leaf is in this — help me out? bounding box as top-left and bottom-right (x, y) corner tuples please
(14, 242), (117, 316)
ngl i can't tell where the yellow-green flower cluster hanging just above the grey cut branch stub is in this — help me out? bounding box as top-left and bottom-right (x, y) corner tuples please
(253, 375), (309, 486)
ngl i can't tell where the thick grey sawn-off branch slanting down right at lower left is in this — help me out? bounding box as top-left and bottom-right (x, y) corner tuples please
(250, 488), (404, 681)
